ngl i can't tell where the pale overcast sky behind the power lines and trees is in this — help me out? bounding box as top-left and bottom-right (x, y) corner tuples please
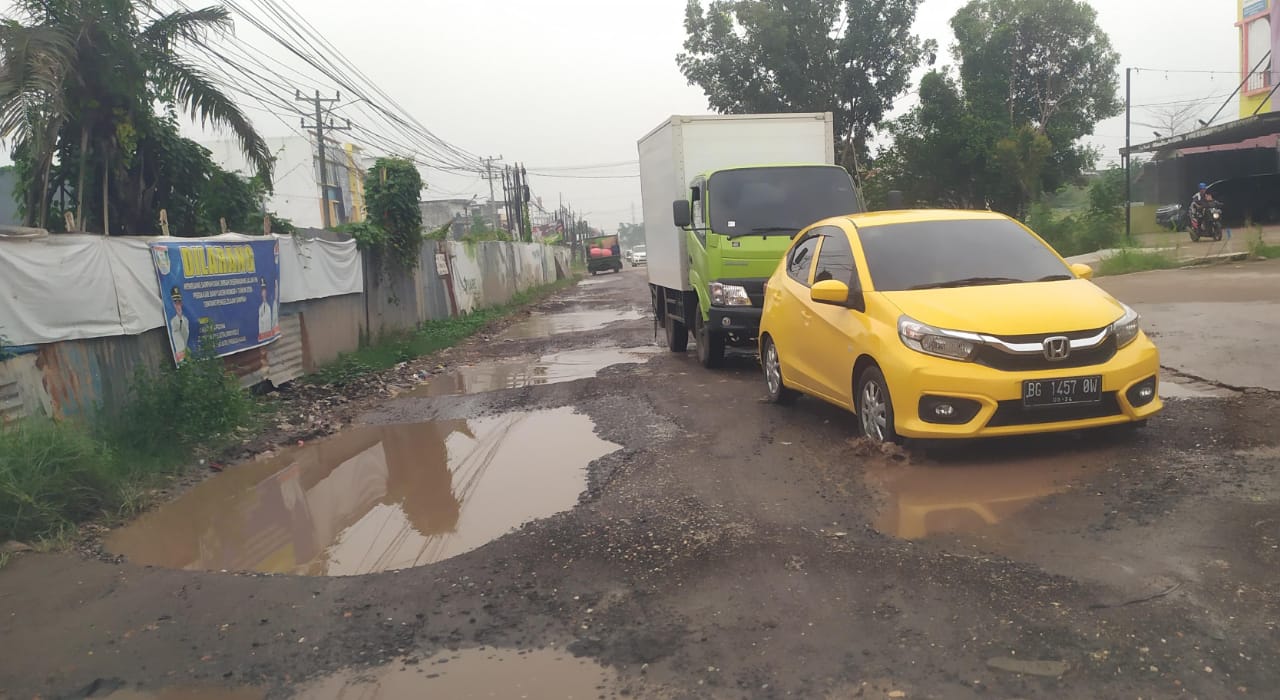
(152, 0), (1239, 228)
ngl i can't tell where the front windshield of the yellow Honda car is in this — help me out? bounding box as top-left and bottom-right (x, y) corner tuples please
(858, 219), (1075, 292)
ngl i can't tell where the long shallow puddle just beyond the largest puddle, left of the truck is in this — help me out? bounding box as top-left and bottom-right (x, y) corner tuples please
(408, 347), (660, 397)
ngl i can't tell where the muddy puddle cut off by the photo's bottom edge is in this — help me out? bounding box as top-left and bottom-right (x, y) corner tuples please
(294, 649), (611, 700)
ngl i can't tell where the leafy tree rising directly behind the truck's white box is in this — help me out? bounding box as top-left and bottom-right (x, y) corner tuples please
(676, 0), (936, 169)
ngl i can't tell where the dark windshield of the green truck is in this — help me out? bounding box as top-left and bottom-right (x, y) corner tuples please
(707, 165), (859, 237)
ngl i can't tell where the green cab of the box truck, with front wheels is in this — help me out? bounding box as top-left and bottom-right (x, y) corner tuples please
(654, 164), (860, 367)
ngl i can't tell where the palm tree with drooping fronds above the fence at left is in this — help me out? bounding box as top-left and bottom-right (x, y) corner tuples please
(0, 0), (271, 233)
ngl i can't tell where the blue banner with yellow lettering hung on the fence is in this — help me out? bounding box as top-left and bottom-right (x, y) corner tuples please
(151, 238), (280, 363)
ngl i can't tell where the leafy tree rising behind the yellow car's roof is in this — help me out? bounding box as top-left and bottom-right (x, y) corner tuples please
(879, 0), (1121, 216)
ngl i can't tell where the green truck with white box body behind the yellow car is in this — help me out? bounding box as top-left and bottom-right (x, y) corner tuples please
(637, 113), (863, 367)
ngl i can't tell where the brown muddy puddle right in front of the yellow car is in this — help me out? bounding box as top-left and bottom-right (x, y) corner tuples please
(864, 438), (1111, 540)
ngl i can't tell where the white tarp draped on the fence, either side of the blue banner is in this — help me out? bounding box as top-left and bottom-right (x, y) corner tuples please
(0, 233), (365, 346)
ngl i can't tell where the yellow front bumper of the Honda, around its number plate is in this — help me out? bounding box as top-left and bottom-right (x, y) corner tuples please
(882, 334), (1164, 439)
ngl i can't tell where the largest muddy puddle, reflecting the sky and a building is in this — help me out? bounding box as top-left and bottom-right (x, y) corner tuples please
(108, 408), (618, 576)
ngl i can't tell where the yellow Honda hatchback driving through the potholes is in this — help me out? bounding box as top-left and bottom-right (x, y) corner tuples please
(759, 210), (1164, 441)
